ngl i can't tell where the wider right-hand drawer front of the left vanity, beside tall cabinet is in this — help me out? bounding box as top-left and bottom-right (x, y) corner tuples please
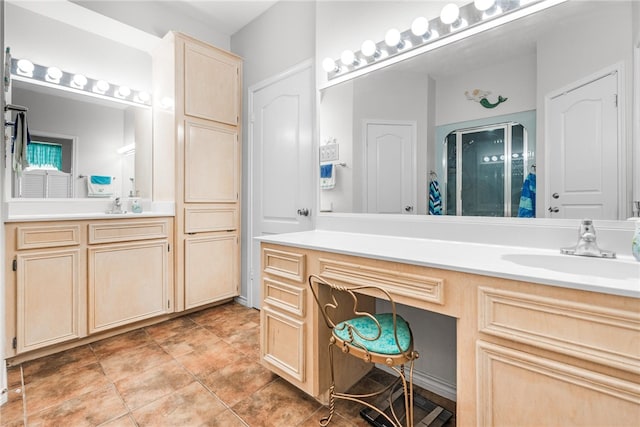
(89, 221), (169, 244)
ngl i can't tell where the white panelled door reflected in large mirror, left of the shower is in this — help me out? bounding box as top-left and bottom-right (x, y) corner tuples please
(364, 121), (416, 214)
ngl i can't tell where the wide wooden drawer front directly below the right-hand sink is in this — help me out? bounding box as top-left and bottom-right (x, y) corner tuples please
(478, 287), (640, 373)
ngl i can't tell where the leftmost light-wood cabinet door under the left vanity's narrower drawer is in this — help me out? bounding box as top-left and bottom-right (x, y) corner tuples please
(16, 249), (80, 353)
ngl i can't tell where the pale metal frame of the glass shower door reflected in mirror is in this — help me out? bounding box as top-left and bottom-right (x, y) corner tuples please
(442, 121), (535, 218)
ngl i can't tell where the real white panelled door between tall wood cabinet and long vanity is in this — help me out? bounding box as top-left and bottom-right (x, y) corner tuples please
(247, 61), (318, 308)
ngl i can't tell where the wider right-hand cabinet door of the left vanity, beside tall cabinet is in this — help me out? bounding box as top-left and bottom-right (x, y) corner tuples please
(89, 240), (172, 333)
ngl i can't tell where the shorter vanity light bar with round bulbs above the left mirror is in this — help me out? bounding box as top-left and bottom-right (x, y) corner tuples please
(11, 58), (151, 107)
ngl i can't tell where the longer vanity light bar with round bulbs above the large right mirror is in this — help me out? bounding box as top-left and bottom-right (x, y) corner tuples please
(323, 0), (567, 87)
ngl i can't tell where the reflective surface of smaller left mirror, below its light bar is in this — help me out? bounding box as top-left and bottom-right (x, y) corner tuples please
(11, 80), (151, 198)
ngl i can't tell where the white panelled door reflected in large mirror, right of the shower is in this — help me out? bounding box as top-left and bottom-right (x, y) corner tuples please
(545, 72), (619, 219)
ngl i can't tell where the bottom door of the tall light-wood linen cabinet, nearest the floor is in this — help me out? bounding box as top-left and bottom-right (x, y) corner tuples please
(184, 234), (239, 309)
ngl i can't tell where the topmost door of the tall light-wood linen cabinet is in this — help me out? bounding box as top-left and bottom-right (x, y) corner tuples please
(184, 42), (240, 126)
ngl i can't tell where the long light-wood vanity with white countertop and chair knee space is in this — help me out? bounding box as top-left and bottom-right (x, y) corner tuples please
(260, 230), (640, 426)
